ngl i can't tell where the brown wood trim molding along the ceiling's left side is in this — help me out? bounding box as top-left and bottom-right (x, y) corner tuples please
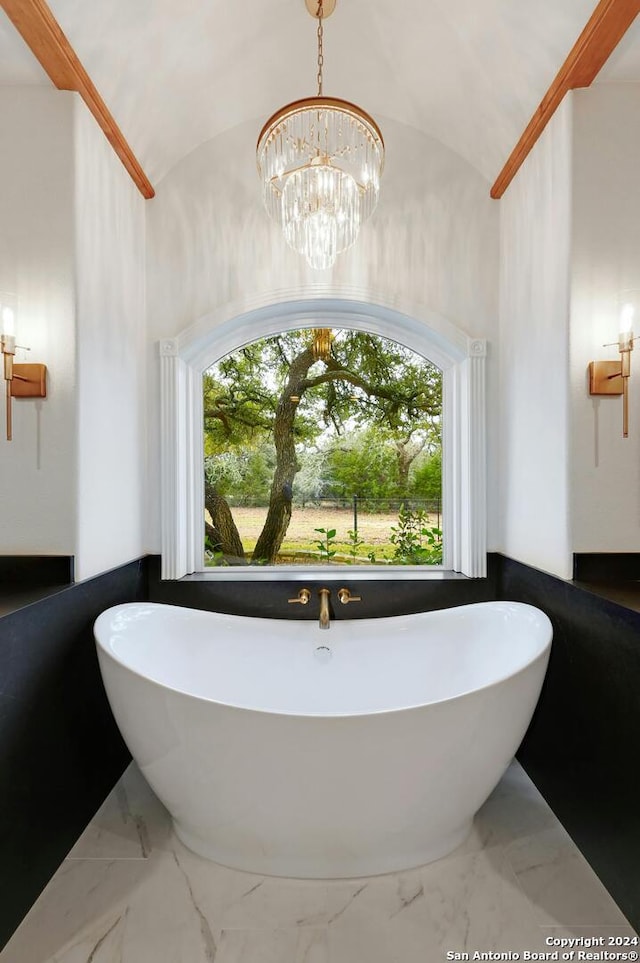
(0, 0), (155, 199)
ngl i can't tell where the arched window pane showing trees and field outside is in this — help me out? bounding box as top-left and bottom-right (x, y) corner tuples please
(203, 328), (442, 568)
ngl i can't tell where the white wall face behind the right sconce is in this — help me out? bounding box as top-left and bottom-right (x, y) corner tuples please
(570, 84), (640, 552)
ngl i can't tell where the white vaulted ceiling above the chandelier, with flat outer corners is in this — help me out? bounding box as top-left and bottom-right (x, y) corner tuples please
(0, 0), (640, 184)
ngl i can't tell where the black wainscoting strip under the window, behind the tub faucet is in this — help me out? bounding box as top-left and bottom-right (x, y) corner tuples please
(149, 555), (498, 621)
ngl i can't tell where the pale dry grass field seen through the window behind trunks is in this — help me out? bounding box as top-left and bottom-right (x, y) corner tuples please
(224, 506), (439, 562)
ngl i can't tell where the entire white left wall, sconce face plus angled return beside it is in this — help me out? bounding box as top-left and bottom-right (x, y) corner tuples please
(0, 87), (146, 579)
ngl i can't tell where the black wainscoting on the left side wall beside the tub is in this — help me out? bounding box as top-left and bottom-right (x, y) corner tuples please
(0, 561), (147, 947)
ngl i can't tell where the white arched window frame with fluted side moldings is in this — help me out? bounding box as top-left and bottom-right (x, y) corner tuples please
(159, 297), (487, 581)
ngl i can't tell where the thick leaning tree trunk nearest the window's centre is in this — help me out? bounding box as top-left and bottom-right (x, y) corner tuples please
(253, 348), (315, 564)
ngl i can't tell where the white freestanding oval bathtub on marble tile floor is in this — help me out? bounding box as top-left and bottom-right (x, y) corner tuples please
(95, 602), (552, 879)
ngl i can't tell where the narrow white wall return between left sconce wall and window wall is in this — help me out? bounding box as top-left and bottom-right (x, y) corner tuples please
(75, 100), (146, 579)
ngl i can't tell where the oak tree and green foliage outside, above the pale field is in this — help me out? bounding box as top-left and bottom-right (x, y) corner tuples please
(203, 330), (441, 564)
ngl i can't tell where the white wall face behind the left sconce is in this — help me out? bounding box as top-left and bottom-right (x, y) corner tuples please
(0, 87), (76, 555)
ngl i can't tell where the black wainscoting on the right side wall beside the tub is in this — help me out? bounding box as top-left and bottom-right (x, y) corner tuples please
(498, 557), (640, 930)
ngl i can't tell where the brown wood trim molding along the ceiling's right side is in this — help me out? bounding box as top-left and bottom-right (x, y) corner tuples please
(491, 0), (640, 199)
